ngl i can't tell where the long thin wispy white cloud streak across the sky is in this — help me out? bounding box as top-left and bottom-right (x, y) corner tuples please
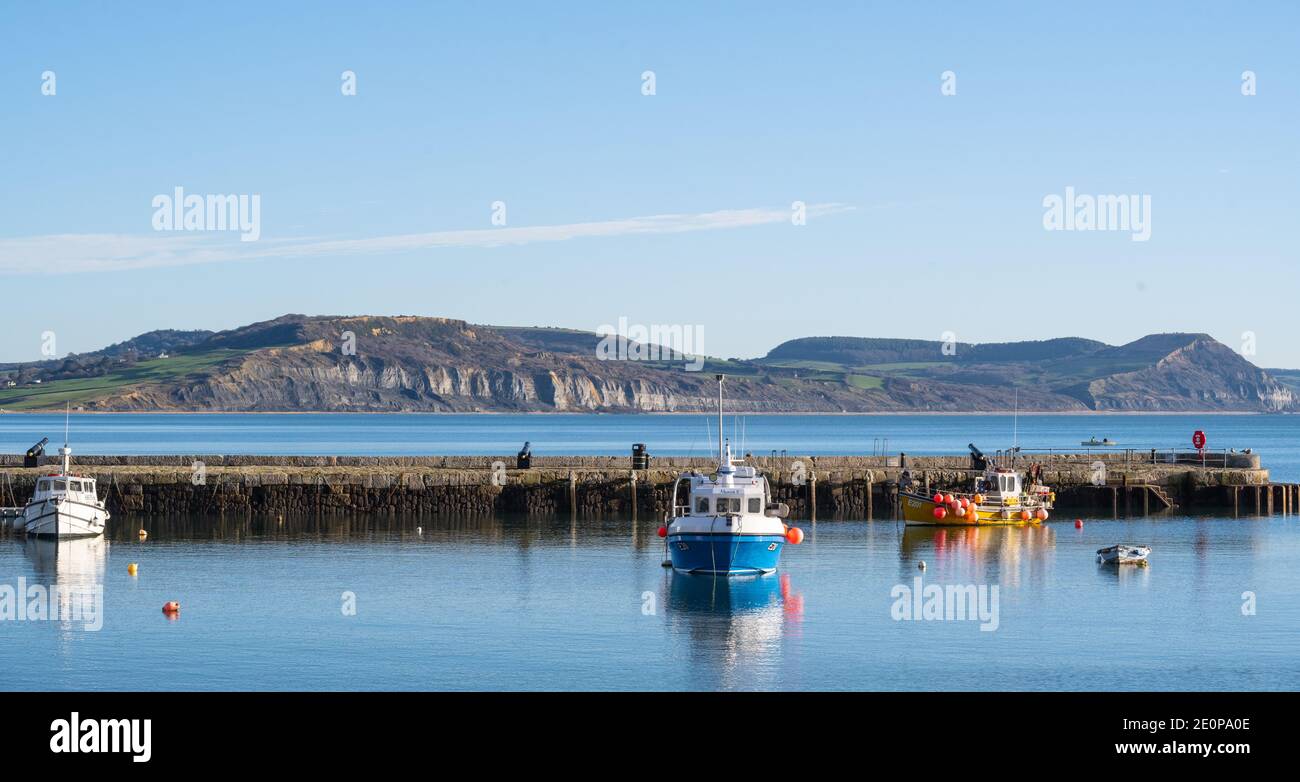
(0, 204), (853, 274)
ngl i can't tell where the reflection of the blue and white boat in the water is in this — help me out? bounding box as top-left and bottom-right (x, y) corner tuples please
(667, 572), (803, 690)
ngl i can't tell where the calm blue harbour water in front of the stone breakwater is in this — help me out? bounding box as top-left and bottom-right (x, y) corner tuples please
(0, 517), (1300, 690)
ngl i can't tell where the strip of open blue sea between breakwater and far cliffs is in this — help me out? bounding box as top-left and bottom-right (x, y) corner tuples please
(0, 413), (1300, 481)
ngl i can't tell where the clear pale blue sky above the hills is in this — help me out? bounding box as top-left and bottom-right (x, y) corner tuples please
(0, 3), (1300, 366)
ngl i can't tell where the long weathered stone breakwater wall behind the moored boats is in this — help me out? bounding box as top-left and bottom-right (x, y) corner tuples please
(0, 452), (1300, 518)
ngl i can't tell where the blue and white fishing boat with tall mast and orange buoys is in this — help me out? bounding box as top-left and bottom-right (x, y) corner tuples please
(660, 375), (803, 575)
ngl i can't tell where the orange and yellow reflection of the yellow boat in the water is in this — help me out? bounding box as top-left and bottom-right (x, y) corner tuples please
(900, 525), (1056, 586)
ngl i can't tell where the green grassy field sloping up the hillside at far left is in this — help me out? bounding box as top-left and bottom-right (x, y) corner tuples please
(0, 349), (246, 410)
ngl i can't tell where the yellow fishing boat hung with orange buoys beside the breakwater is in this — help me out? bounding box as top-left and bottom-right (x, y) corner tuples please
(898, 468), (1056, 526)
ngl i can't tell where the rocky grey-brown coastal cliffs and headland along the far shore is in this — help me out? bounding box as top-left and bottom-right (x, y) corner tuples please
(0, 316), (1297, 412)
